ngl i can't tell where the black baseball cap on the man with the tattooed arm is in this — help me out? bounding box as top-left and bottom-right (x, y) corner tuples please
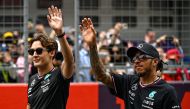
(127, 43), (160, 60)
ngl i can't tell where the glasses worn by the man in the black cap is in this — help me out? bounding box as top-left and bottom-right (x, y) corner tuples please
(131, 54), (154, 63)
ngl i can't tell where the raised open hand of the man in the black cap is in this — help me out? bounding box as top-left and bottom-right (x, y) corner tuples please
(80, 18), (96, 45)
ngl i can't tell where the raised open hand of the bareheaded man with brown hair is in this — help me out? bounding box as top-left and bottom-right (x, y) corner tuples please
(47, 6), (63, 31)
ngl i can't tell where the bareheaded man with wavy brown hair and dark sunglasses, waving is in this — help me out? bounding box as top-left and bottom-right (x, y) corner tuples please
(27, 6), (74, 109)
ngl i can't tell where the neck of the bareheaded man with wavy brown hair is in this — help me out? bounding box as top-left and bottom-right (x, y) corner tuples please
(38, 64), (54, 76)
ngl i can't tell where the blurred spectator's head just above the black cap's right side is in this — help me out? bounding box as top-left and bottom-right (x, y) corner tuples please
(144, 29), (156, 47)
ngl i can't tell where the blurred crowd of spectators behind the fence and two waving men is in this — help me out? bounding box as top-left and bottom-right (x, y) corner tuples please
(0, 20), (190, 83)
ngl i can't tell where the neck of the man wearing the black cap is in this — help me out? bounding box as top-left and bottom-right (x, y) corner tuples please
(140, 71), (158, 84)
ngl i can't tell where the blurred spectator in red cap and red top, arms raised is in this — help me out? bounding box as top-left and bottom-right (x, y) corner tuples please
(156, 35), (184, 81)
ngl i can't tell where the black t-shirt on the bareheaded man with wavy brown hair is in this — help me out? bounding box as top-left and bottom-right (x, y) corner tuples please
(28, 68), (70, 109)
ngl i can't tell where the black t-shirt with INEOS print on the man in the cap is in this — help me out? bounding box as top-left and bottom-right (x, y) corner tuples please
(110, 74), (181, 109)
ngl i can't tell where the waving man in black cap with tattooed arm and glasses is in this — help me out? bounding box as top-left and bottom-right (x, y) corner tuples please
(80, 18), (180, 109)
